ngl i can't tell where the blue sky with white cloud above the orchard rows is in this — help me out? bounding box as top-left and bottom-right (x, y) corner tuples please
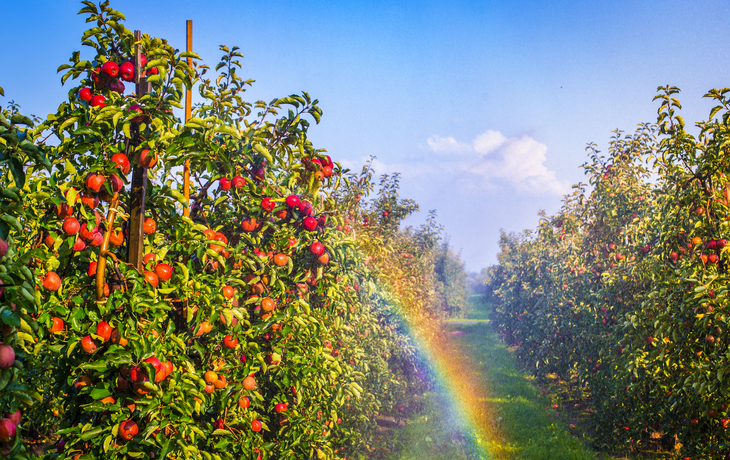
(0, 0), (730, 271)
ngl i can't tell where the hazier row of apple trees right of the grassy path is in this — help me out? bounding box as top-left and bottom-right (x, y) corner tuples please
(487, 87), (730, 458)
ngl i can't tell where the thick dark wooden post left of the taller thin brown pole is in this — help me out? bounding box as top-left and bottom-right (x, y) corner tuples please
(127, 30), (151, 271)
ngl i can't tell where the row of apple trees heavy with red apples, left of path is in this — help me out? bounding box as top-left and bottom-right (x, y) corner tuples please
(0, 1), (463, 459)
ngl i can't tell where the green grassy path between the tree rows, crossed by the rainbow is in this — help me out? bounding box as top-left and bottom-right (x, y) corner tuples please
(388, 299), (599, 460)
